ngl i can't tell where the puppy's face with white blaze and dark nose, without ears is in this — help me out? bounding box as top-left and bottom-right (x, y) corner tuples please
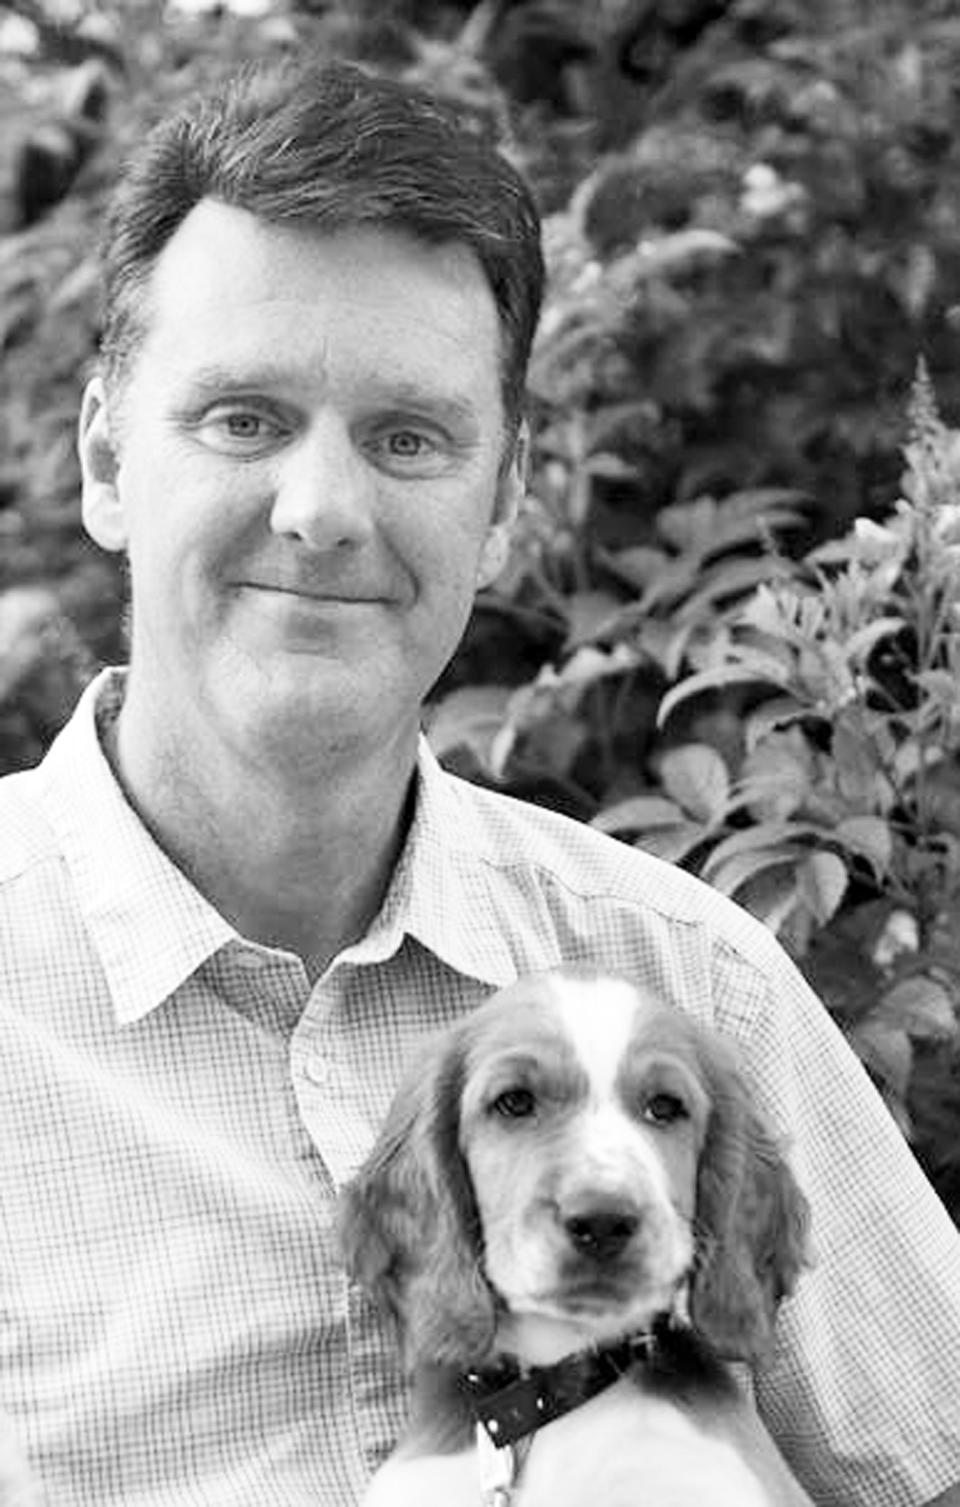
(460, 974), (710, 1340)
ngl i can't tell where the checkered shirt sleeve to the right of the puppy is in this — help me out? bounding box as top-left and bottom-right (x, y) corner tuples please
(738, 943), (960, 1507)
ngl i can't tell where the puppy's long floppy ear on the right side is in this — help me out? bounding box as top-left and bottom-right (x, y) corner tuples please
(690, 1049), (808, 1361)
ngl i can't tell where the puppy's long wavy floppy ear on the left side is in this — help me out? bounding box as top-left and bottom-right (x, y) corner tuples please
(339, 1032), (494, 1367)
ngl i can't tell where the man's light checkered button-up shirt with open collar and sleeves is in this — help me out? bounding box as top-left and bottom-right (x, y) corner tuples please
(0, 672), (960, 1507)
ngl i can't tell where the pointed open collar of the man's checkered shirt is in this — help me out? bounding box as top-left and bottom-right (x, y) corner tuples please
(38, 669), (520, 1023)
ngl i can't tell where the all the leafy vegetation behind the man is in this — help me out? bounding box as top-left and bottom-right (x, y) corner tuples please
(0, 0), (960, 1221)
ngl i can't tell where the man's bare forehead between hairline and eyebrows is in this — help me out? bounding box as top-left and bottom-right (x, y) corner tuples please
(131, 200), (502, 399)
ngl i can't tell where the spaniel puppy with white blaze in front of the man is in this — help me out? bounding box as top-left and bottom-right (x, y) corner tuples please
(341, 971), (809, 1507)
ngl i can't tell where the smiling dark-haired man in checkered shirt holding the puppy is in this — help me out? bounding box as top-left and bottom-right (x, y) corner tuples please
(0, 50), (960, 1507)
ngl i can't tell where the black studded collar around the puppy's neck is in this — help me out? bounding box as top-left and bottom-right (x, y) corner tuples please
(458, 1329), (659, 1448)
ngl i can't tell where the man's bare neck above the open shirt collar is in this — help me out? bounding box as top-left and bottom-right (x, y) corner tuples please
(109, 690), (416, 978)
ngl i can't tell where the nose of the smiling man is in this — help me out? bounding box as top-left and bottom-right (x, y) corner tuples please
(270, 414), (375, 550)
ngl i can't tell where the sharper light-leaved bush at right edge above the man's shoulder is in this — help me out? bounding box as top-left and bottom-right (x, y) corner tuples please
(614, 377), (960, 1126)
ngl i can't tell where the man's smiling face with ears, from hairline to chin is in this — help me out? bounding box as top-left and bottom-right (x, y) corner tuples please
(81, 200), (520, 765)
